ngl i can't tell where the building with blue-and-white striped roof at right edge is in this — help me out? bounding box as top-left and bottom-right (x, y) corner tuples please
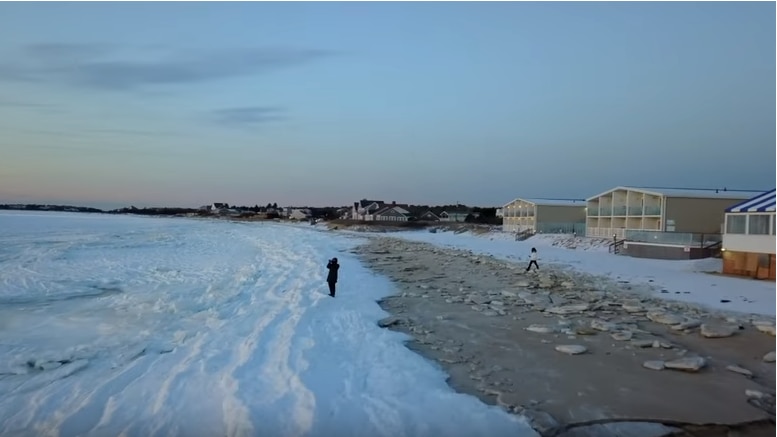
(722, 190), (777, 280)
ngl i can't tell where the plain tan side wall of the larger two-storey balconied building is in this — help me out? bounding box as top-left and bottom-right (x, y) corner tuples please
(662, 197), (748, 234)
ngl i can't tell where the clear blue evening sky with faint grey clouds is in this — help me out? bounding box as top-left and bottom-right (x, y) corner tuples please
(0, 2), (777, 207)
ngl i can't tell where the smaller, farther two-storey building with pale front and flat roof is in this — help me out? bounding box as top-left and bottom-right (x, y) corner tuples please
(502, 198), (586, 235)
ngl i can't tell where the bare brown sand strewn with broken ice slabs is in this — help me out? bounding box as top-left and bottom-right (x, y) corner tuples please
(355, 237), (775, 437)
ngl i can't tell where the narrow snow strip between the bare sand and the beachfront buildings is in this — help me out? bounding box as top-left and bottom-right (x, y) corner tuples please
(384, 231), (777, 317)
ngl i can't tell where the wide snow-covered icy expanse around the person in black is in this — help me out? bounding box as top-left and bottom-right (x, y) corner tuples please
(0, 212), (536, 437)
